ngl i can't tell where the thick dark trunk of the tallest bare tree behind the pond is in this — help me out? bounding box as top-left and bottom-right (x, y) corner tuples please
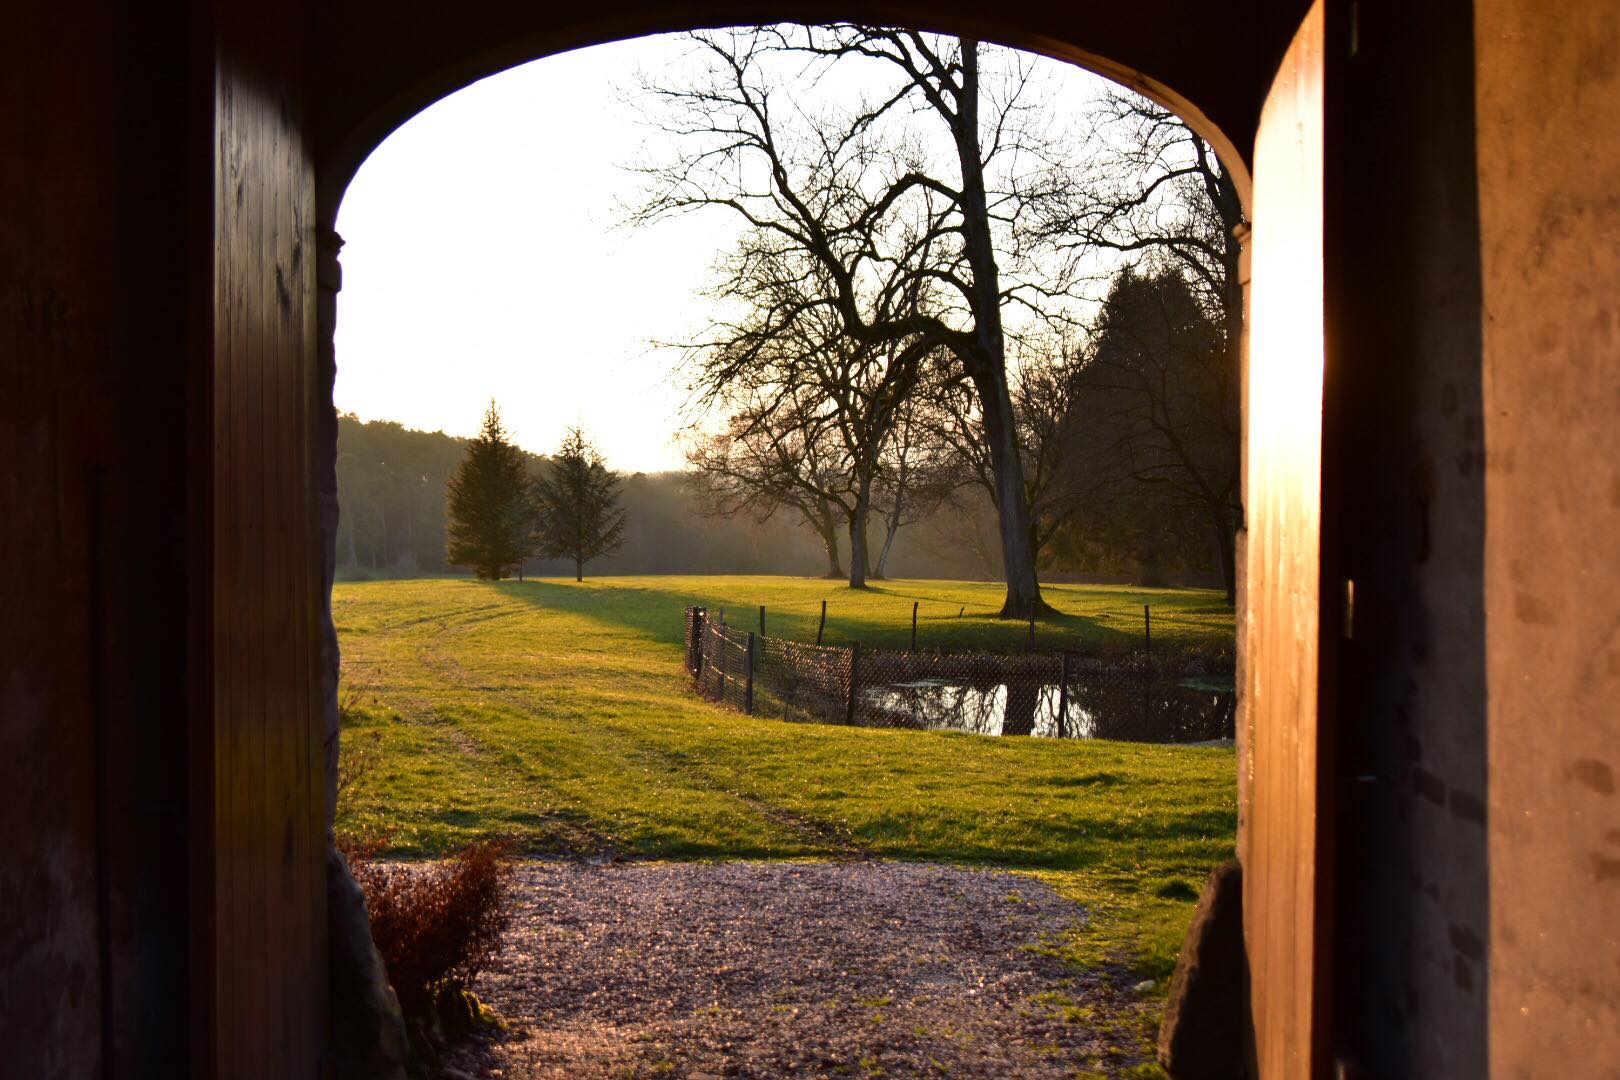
(953, 37), (1047, 619)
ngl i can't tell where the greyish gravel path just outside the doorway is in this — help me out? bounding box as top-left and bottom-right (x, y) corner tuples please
(437, 861), (1149, 1080)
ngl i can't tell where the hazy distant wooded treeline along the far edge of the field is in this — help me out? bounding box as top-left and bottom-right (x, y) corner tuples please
(337, 413), (1215, 585)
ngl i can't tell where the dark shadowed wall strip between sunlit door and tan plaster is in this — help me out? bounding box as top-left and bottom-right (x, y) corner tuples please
(1327, 0), (1490, 1077)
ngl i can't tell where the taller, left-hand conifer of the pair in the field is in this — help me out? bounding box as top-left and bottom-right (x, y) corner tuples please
(444, 402), (535, 580)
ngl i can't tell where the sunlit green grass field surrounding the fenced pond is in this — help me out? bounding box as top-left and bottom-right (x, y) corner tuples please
(334, 576), (1236, 978)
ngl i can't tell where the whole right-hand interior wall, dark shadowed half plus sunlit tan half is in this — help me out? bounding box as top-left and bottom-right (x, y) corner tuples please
(1328, 0), (1620, 1077)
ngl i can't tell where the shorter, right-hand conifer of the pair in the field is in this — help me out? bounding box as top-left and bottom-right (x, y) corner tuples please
(533, 427), (624, 581)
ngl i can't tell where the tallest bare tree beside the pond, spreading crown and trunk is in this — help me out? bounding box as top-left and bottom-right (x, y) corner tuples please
(635, 24), (1088, 617)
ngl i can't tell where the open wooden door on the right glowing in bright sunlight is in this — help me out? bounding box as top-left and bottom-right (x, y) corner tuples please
(1239, 0), (1327, 1080)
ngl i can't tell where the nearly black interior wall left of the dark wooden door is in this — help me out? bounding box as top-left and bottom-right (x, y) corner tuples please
(0, 0), (196, 1080)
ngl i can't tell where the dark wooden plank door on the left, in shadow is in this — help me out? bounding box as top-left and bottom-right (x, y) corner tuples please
(212, 8), (326, 1077)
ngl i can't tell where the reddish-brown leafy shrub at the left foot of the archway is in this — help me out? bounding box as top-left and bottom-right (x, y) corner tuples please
(343, 840), (512, 1015)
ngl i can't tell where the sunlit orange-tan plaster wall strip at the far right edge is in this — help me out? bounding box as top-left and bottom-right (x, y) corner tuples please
(1474, 0), (1620, 1077)
